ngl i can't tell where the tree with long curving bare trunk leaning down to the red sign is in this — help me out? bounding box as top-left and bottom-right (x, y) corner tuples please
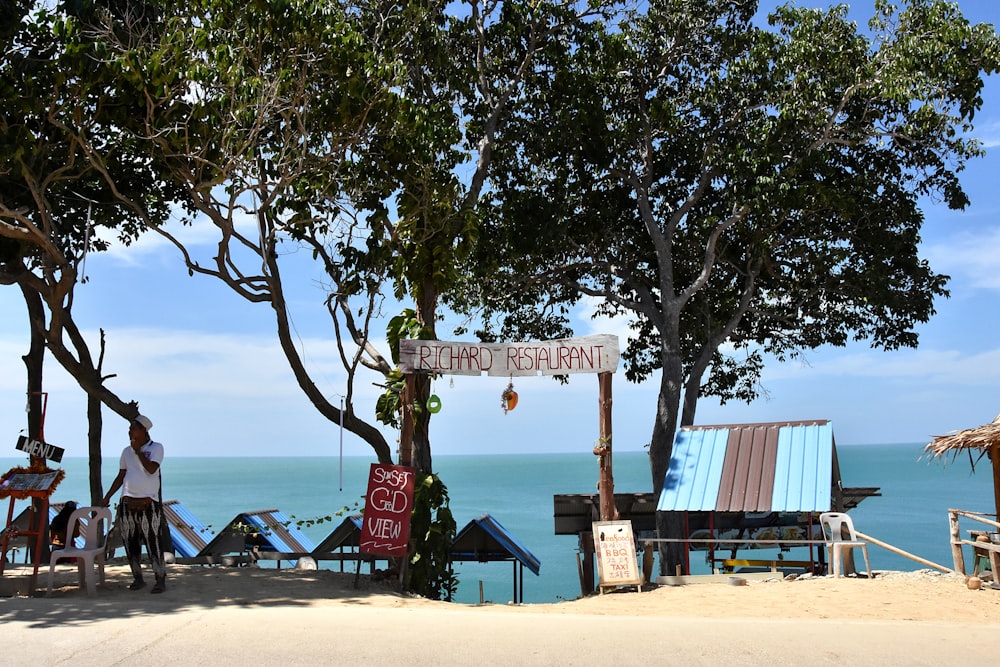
(76, 0), (416, 463)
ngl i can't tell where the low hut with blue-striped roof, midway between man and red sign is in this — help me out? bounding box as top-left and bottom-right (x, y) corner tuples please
(198, 509), (316, 567)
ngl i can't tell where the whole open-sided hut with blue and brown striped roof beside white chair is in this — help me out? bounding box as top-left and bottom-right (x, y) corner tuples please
(657, 420), (879, 572)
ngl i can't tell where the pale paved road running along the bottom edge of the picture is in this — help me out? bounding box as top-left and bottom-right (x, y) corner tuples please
(0, 596), (1000, 667)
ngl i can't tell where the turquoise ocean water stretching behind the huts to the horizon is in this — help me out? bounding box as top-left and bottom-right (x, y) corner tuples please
(0, 444), (994, 603)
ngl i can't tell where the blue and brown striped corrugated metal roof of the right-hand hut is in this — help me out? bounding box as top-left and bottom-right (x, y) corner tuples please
(656, 420), (840, 512)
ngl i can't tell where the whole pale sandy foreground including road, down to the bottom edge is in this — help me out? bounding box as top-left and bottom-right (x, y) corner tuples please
(0, 565), (1000, 667)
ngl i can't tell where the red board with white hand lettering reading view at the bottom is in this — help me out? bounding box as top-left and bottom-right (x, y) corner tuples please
(359, 463), (414, 556)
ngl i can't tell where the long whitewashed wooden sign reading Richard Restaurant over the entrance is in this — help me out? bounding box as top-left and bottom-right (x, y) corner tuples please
(399, 334), (620, 377)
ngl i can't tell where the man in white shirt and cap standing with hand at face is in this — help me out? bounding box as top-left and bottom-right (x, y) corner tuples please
(102, 415), (167, 593)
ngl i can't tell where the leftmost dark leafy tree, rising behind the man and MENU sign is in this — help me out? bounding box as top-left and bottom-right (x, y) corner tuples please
(0, 2), (169, 502)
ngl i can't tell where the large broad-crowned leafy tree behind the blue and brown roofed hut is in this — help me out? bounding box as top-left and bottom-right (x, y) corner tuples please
(463, 0), (1000, 571)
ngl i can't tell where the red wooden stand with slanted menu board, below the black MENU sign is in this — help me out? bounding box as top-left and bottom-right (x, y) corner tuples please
(0, 467), (65, 593)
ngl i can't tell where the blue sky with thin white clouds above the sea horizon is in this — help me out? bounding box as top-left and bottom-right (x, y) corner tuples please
(0, 0), (1000, 459)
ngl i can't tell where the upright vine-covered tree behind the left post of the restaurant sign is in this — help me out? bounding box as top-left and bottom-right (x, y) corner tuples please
(362, 0), (605, 471)
